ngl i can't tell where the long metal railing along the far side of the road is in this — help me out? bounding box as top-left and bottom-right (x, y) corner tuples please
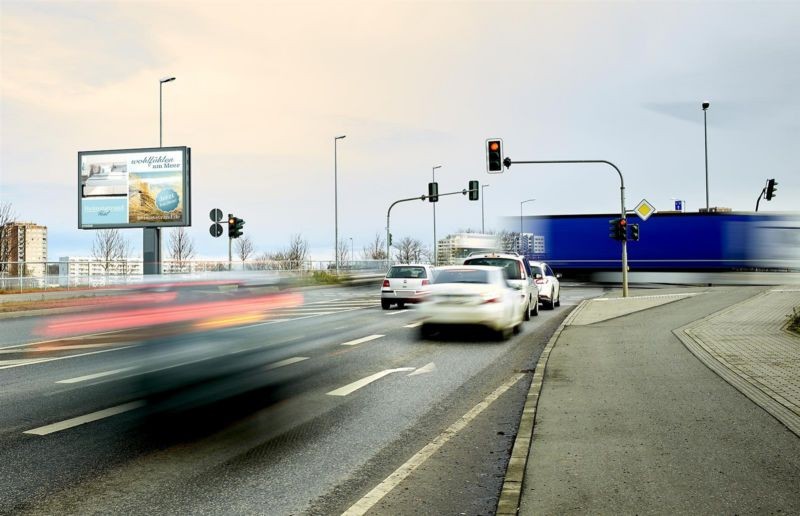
(0, 260), (391, 292)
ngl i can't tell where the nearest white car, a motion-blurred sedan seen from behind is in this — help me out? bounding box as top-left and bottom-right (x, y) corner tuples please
(412, 265), (527, 339)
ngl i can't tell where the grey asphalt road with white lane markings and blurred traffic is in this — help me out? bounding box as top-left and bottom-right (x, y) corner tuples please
(0, 287), (603, 514)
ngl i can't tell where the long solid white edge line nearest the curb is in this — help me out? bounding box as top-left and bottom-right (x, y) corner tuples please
(342, 374), (525, 516)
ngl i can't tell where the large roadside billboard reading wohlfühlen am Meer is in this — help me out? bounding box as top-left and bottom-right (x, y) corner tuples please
(78, 147), (191, 229)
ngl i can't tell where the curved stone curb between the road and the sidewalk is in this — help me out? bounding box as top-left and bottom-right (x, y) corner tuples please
(495, 299), (590, 516)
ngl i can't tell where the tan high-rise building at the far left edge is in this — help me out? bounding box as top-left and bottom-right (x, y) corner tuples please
(0, 222), (47, 277)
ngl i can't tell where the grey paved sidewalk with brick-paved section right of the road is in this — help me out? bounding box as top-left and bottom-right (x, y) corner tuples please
(498, 287), (800, 515)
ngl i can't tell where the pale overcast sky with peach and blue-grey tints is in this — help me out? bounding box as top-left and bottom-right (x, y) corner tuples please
(0, 0), (800, 260)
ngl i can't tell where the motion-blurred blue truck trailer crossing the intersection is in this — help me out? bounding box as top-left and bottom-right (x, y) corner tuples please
(505, 212), (800, 272)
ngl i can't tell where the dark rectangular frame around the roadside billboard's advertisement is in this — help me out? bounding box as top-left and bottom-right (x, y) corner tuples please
(76, 145), (192, 229)
